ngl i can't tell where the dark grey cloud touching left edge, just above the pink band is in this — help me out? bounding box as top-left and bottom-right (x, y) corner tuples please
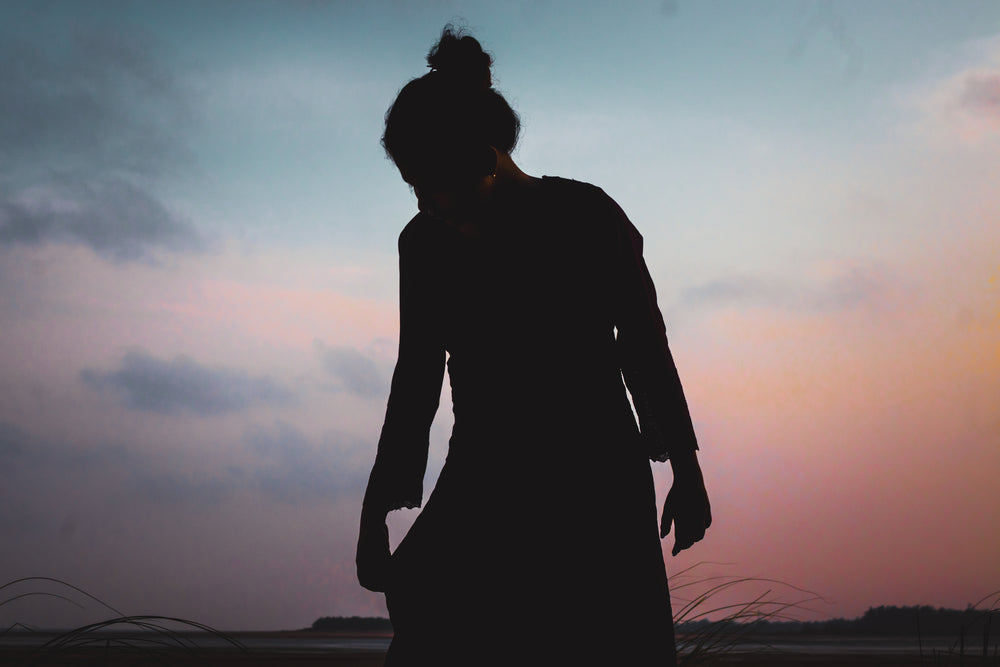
(0, 178), (205, 260)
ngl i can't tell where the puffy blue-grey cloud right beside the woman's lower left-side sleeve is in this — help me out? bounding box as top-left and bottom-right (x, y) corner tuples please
(246, 421), (372, 504)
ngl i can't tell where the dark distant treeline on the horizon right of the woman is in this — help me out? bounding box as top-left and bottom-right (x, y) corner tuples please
(677, 606), (1000, 637)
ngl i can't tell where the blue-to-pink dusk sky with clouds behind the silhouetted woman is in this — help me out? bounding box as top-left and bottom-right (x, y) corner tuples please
(0, 0), (1000, 630)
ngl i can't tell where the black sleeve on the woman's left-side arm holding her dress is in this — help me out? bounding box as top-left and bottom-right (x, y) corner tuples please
(364, 226), (445, 511)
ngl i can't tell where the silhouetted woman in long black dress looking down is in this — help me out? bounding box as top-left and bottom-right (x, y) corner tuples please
(357, 27), (711, 665)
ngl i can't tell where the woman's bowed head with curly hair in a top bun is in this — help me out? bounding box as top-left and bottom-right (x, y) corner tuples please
(382, 26), (521, 200)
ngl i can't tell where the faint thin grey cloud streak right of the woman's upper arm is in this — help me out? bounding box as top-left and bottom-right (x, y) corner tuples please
(681, 264), (906, 311)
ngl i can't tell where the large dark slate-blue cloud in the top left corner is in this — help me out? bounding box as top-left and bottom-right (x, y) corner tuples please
(0, 28), (193, 175)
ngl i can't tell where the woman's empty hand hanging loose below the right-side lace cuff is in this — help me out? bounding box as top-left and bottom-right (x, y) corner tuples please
(660, 450), (712, 556)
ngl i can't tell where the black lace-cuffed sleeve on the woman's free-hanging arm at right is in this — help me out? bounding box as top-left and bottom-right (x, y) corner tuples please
(614, 196), (698, 461)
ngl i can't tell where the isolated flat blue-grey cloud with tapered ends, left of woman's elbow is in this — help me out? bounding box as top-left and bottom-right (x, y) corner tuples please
(80, 350), (294, 417)
